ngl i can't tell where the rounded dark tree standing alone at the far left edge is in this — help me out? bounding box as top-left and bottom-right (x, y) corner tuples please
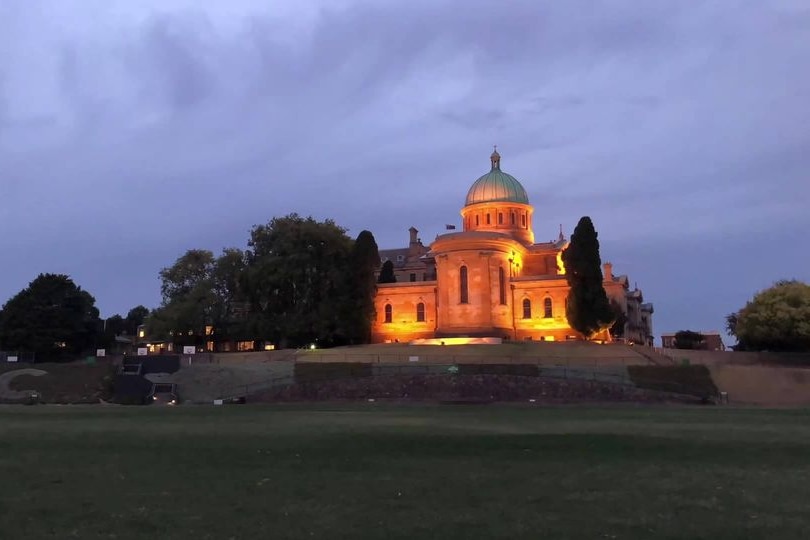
(0, 274), (103, 360)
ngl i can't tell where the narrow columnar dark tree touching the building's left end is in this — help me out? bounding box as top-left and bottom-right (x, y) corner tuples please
(345, 231), (380, 343)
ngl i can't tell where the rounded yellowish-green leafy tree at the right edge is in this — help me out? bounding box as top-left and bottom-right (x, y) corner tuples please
(726, 280), (810, 351)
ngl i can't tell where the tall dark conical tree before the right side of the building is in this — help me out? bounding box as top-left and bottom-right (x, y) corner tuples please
(562, 216), (615, 338)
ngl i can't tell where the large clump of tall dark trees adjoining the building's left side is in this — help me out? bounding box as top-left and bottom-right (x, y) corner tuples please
(147, 214), (380, 347)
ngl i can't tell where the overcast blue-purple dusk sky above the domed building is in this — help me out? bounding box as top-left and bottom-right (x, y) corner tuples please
(0, 0), (810, 344)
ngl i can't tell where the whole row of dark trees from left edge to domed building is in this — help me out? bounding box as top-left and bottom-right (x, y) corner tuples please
(0, 214), (380, 360)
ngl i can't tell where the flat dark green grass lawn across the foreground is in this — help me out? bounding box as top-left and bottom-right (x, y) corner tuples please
(0, 404), (810, 540)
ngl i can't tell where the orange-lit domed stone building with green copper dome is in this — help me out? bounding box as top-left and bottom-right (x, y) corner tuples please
(373, 151), (653, 345)
